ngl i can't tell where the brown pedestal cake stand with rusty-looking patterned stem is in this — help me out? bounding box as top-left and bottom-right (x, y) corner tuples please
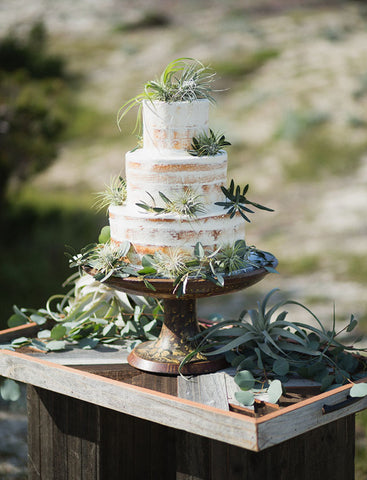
(84, 253), (278, 375)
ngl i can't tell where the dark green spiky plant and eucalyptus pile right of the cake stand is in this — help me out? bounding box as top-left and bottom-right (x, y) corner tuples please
(180, 289), (367, 405)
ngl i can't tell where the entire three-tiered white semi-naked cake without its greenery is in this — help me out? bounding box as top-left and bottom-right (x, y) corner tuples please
(109, 99), (245, 261)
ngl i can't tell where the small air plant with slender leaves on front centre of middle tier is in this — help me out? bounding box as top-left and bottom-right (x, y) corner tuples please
(136, 188), (206, 218)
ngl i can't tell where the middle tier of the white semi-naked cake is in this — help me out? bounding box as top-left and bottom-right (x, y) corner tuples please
(125, 148), (227, 207)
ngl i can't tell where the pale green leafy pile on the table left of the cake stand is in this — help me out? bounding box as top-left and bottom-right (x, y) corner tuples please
(4, 272), (163, 352)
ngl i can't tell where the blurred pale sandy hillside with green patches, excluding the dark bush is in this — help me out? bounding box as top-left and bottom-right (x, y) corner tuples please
(0, 0), (367, 478)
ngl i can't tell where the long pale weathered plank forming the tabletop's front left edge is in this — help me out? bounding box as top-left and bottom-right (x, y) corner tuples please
(0, 350), (256, 449)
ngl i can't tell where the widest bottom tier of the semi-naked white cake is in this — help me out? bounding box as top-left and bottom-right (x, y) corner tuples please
(109, 206), (245, 258)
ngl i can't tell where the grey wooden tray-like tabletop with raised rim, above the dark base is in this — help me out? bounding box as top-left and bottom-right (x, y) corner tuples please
(0, 325), (367, 452)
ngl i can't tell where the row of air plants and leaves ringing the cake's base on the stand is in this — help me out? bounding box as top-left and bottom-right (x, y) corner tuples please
(68, 232), (276, 297)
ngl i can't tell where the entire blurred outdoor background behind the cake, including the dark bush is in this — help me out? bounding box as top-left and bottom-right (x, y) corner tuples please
(0, 0), (367, 479)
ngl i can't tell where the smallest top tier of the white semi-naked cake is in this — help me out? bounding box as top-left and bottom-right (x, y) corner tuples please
(143, 99), (209, 152)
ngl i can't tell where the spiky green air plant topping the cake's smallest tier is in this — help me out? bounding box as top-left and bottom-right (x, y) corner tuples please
(117, 57), (215, 130)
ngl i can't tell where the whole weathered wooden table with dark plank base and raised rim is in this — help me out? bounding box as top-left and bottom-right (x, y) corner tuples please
(0, 326), (367, 480)
